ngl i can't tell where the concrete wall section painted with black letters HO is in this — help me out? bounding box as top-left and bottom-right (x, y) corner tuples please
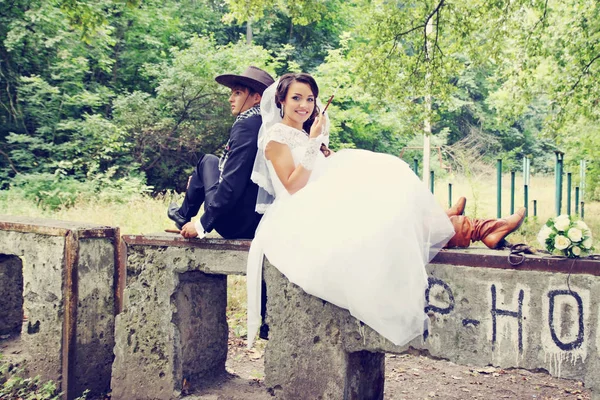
(421, 261), (600, 397)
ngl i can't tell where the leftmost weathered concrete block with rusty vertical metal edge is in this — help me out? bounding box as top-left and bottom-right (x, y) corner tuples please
(0, 216), (118, 398)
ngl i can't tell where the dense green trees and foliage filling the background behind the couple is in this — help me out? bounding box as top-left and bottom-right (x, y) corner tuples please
(0, 0), (600, 199)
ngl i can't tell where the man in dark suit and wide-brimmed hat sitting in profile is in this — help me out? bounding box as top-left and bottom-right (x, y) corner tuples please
(167, 66), (274, 239)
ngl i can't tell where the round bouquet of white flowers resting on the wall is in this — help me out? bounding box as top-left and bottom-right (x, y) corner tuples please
(537, 215), (593, 258)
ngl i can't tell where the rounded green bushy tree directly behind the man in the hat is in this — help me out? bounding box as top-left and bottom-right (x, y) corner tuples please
(114, 37), (276, 189)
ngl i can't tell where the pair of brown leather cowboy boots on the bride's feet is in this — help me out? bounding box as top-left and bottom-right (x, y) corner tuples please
(445, 207), (526, 249)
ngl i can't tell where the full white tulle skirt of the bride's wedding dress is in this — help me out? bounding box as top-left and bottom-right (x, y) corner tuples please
(248, 150), (454, 345)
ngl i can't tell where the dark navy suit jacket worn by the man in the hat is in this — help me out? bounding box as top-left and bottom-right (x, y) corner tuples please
(200, 114), (262, 239)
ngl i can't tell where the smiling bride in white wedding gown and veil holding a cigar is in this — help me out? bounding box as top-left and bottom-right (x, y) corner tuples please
(247, 73), (454, 346)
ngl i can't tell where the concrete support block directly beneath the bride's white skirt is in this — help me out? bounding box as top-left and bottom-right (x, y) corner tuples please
(264, 263), (385, 400)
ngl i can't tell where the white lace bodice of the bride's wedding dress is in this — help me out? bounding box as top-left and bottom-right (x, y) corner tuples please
(264, 123), (326, 199)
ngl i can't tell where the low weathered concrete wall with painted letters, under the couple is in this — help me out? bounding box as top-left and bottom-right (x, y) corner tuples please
(0, 225), (600, 400)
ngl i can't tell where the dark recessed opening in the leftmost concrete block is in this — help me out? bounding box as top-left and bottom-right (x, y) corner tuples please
(0, 254), (23, 335)
